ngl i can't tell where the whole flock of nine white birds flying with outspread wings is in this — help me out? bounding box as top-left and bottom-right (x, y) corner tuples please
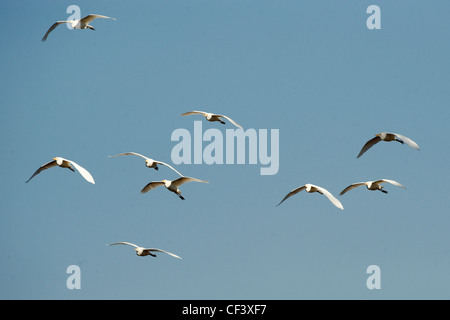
(32, 14), (420, 259)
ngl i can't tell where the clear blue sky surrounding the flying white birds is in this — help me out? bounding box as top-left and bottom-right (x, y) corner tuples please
(0, 0), (450, 299)
